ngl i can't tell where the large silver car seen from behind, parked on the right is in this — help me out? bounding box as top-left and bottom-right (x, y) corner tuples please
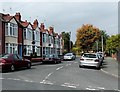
(79, 53), (102, 69)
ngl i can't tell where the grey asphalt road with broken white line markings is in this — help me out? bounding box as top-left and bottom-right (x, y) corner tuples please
(0, 58), (118, 92)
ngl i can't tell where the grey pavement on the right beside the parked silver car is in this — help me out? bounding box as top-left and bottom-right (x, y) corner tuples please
(101, 57), (120, 78)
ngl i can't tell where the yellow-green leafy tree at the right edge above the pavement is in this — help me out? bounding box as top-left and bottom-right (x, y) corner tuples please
(106, 34), (120, 53)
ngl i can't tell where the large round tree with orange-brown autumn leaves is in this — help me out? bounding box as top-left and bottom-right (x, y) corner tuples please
(76, 24), (100, 51)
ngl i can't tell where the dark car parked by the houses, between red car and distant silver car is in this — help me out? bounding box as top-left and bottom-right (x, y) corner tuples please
(42, 54), (61, 64)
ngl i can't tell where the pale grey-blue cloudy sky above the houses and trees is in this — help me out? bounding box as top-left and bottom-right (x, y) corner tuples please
(0, 0), (118, 43)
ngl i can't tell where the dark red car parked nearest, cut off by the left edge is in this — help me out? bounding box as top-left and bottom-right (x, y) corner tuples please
(0, 54), (31, 71)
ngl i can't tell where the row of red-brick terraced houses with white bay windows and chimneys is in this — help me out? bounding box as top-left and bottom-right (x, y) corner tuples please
(0, 13), (63, 57)
